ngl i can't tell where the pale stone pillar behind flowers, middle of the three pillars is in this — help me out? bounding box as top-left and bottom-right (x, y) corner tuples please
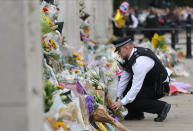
(58, 0), (81, 50)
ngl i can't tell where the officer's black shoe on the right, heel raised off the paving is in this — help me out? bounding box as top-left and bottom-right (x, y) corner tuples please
(154, 103), (171, 122)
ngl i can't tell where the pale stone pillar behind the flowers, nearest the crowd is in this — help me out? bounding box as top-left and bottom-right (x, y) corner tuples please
(85, 0), (113, 43)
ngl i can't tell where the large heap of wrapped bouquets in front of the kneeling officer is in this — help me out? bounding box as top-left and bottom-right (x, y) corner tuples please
(40, 2), (129, 131)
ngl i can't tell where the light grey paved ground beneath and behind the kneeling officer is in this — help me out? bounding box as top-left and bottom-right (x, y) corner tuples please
(122, 43), (193, 131)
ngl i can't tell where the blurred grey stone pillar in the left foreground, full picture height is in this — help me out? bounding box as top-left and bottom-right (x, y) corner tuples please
(0, 0), (43, 131)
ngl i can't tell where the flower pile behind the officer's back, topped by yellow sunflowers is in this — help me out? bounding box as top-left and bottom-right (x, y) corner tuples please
(137, 33), (189, 77)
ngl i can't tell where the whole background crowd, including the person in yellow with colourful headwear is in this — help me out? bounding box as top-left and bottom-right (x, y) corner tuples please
(113, 2), (193, 40)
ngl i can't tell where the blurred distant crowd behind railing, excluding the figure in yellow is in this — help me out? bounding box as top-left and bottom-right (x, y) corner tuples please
(136, 7), (193, 26)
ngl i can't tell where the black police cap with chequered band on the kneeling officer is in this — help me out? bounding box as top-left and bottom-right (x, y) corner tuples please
(112, 36), (131, 52)
